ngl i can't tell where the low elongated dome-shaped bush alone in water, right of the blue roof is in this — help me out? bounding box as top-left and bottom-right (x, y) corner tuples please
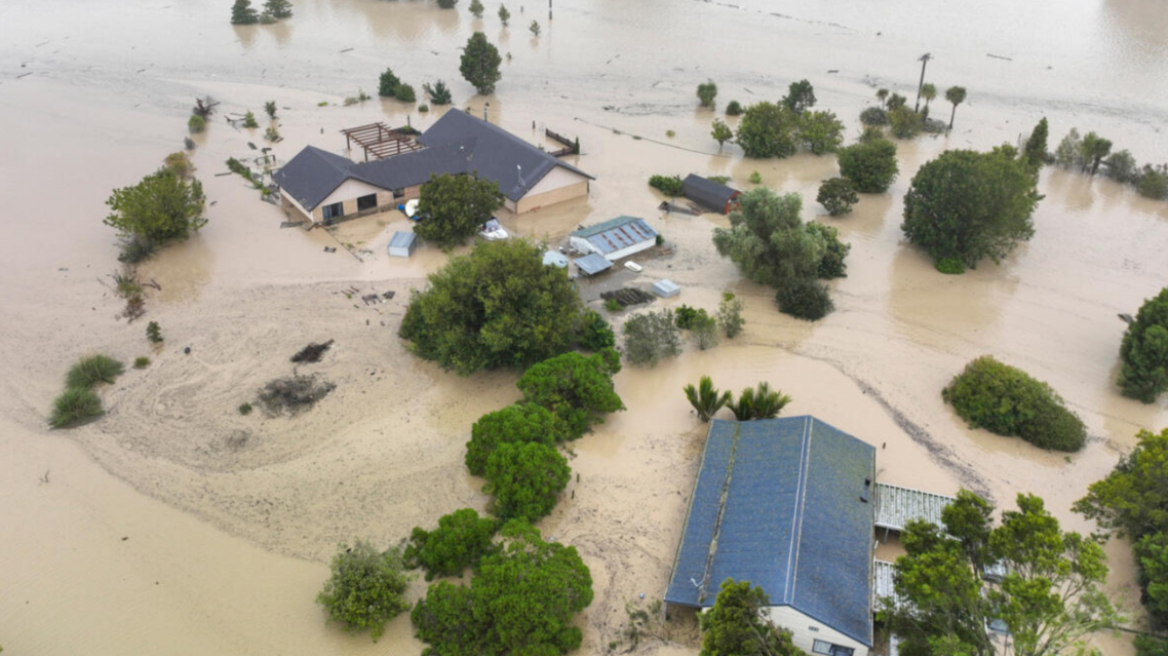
(941, 356), (1086, 452)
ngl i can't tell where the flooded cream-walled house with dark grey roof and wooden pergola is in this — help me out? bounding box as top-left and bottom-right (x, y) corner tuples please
(273, 109), (595, 225)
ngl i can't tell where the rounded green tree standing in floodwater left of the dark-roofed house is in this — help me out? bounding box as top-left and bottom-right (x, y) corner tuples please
(104, 168), (207, 244)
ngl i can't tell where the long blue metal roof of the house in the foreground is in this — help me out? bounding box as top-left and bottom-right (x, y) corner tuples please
(665, 417), (876, 647)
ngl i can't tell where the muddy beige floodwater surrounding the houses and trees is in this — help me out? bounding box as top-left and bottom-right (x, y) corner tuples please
(0, 0), (1168, 656)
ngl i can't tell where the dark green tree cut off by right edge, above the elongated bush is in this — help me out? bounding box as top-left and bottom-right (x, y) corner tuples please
(1118, 287), (1168, 403)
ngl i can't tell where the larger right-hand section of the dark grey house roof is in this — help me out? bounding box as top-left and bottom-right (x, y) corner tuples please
(420, 109), (595, 201)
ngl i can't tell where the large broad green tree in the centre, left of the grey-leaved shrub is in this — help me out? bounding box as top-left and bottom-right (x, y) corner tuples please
(399, 239), (580, 376)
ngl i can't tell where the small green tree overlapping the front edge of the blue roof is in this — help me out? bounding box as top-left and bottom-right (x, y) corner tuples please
(697, 579), (804, 656)
